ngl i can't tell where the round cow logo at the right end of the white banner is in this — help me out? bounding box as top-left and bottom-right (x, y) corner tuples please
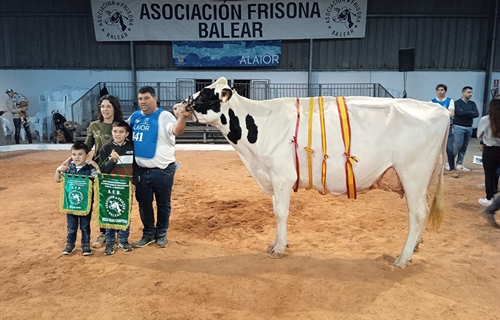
(324, 0), (364, 38)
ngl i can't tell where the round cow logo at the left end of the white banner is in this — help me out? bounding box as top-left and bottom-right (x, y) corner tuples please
(95, 1), (134, 40)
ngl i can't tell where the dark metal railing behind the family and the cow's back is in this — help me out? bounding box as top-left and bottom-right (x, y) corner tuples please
(71, 81), (393, 143)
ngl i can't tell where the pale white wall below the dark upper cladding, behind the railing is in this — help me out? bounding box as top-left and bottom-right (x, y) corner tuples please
(0, 70), (500, 125)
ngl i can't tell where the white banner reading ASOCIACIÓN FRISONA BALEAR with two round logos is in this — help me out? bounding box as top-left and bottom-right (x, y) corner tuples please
(91, 0), (368, 41)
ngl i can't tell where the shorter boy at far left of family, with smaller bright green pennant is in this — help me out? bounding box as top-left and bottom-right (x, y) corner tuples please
(55, 142), (99, 256)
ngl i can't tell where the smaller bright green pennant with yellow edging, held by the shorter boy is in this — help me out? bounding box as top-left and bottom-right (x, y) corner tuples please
(60, 174), (92, 216)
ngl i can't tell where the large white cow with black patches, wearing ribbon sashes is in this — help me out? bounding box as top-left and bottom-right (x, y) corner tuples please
(178, 78), (449, 268)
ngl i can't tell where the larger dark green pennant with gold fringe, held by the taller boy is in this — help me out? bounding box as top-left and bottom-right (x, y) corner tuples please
(96, 174), (132, 230)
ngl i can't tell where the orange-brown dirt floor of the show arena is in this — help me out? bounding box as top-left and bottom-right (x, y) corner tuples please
(0, 146), (500, 320)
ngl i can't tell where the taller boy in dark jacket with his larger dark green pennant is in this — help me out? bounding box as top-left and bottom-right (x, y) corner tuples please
(98, 120), (134, 256)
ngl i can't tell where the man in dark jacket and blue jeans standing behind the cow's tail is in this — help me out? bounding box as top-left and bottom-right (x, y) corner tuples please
(449, 86), (479, 178)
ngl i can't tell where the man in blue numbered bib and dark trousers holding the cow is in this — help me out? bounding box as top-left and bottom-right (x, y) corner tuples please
(129, 86), (191, 248)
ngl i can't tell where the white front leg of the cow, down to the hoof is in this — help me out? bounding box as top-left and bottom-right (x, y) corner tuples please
(267, 186), (292, 259)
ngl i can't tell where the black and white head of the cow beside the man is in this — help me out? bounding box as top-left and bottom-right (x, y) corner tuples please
(182, 77), (233, 124)
